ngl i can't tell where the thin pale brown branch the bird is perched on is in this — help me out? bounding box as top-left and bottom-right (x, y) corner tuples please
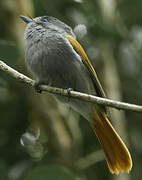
(0, 61), (142, 112)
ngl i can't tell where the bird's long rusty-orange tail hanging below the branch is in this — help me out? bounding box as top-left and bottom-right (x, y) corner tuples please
(93, 110), (132, 174)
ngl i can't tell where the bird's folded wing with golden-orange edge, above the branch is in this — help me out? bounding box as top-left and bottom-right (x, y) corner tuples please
(66, 35), (106, 97)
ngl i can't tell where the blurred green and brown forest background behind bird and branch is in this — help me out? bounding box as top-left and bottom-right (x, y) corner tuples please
(0, 0), (142, 180)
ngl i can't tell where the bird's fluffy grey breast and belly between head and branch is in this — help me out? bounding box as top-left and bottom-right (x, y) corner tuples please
(26, 33), (94, 93)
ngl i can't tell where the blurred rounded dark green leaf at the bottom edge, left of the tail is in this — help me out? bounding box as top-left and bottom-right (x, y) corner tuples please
(23, 165), (75, 180)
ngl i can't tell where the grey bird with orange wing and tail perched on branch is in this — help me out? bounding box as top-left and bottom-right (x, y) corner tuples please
(20, 16), (132, 175)
